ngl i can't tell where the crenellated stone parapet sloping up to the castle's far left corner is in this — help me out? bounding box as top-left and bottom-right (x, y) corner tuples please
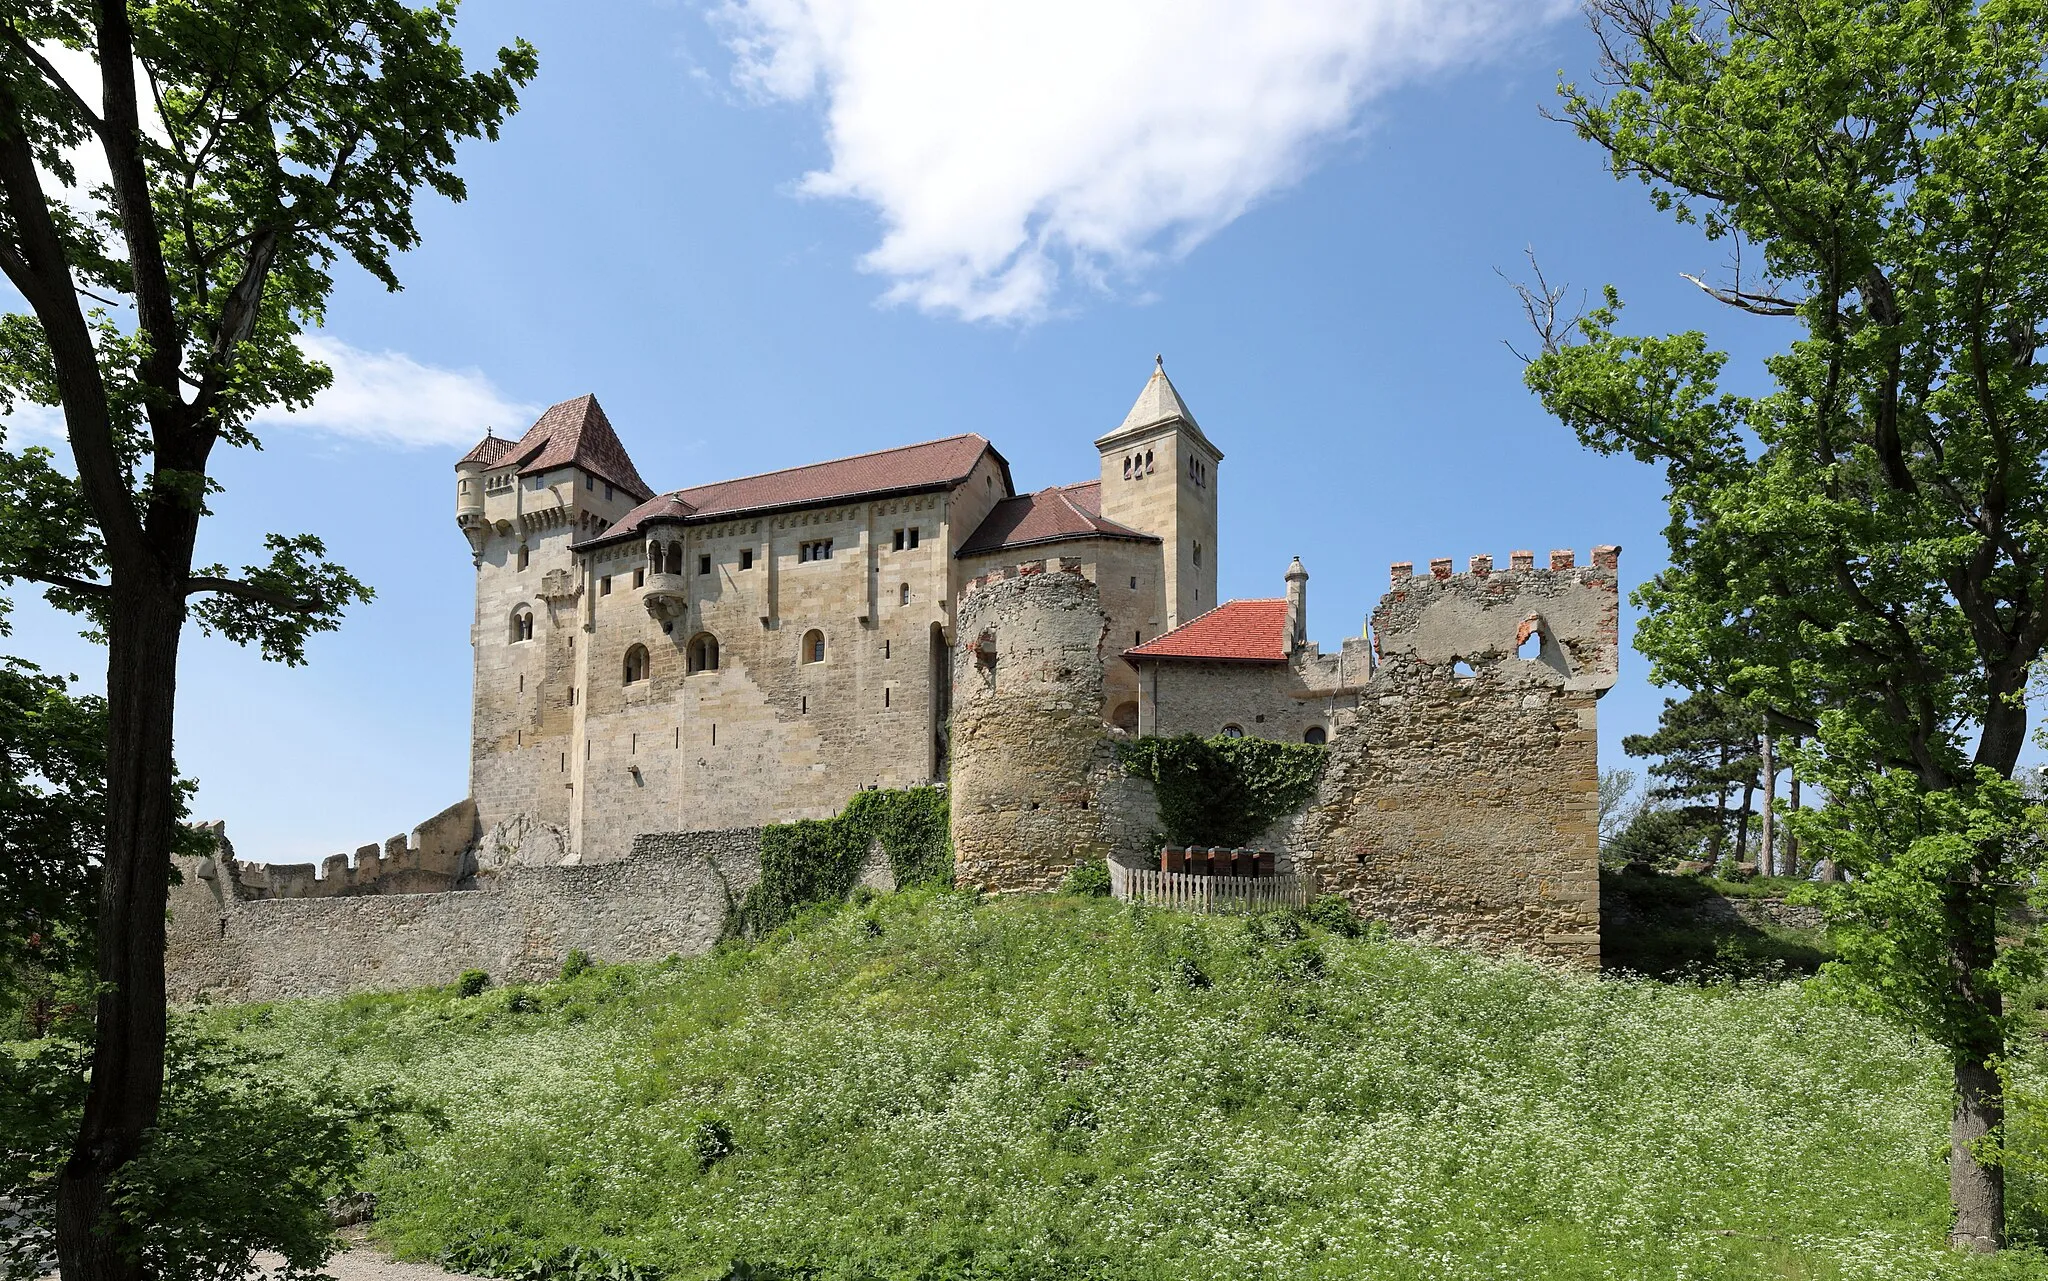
(199, 797), (477, 900)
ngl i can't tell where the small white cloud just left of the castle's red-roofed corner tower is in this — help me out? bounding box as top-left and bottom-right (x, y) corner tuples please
(256, 334), (541, 449)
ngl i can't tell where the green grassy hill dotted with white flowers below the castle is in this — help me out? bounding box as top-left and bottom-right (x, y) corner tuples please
(205, 892), (2048, 1281)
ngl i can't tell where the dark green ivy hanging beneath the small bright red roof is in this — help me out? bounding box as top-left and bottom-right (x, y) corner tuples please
(1116, 734), (1329, 846)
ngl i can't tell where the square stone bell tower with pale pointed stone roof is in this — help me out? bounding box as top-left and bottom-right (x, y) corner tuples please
(1096, 359), (1223, 631)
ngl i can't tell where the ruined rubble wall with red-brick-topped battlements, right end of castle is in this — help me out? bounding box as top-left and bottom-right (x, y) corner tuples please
(1290, 547), (1620, 963)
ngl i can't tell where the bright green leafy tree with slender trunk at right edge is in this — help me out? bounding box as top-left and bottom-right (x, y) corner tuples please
(1526, 0), (2048, 1250)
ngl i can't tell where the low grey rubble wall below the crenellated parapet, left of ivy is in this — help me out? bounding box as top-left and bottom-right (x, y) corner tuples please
(166, 828), (760, 1000)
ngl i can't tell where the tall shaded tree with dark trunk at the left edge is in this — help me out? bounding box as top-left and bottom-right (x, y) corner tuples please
(0, 0), (535, 1281)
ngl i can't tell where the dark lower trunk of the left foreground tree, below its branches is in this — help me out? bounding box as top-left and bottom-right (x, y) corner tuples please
(57, 586), (184, 1281)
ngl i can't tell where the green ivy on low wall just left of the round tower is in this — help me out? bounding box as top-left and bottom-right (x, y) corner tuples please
(725, 787), (952, 939)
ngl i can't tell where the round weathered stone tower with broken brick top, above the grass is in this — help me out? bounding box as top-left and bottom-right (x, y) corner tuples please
(950, 560), (1116, 890)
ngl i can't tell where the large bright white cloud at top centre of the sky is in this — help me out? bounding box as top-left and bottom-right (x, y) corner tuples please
(717, 0), (1573, 320)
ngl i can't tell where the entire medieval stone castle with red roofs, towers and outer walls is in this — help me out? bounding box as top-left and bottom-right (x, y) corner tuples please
(170, 363), (1620, 998)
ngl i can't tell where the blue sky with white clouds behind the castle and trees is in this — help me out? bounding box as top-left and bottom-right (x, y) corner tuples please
(6, 0), (1788, 861)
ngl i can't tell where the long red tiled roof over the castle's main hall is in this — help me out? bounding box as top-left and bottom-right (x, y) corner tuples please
(588, 432), (1010, 543)
